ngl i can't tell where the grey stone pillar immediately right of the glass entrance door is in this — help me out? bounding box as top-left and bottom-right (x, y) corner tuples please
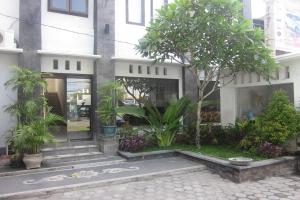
(94, 0), (118, 154)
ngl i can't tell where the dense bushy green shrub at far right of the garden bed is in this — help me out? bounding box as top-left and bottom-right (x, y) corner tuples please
(240, 90), (300, 149)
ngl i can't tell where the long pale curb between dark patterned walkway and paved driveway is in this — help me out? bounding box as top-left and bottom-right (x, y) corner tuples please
(0, 166), (206, 200)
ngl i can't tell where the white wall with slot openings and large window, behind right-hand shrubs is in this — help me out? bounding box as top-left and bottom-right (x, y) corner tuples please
(221, 53), (300, 125)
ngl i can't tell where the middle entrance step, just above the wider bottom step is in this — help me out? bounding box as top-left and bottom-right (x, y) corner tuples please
(42, 145), (99, 156)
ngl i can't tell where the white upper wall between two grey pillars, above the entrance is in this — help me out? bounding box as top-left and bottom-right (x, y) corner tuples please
(41, 0), (94, 54)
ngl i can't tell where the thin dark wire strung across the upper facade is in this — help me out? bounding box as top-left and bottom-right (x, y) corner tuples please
(0, 13), (136, 46)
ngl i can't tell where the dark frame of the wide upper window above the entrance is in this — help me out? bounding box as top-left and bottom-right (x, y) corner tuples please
(48, 0), (89, 17)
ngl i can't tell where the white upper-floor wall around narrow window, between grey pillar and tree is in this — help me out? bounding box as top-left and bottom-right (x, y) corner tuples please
(115, 0), (163, 58)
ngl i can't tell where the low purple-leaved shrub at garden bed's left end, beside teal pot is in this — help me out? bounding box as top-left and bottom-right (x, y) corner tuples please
(119, 135), (145, 152)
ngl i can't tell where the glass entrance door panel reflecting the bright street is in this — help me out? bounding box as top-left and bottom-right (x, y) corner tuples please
(66, 78), (92, 133)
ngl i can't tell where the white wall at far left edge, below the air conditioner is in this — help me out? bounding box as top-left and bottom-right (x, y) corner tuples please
(0, 52), (18, 148)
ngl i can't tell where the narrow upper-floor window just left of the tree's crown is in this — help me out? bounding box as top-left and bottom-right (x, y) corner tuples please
(126, 0), (145, 26)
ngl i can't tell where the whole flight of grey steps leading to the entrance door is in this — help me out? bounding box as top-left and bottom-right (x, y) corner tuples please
(42, 141), (125, 167)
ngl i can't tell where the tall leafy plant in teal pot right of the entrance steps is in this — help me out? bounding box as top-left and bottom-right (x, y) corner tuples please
(97, 81), (144, 136)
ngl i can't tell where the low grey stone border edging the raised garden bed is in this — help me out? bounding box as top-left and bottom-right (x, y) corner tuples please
(118, 150), (300, 183)
